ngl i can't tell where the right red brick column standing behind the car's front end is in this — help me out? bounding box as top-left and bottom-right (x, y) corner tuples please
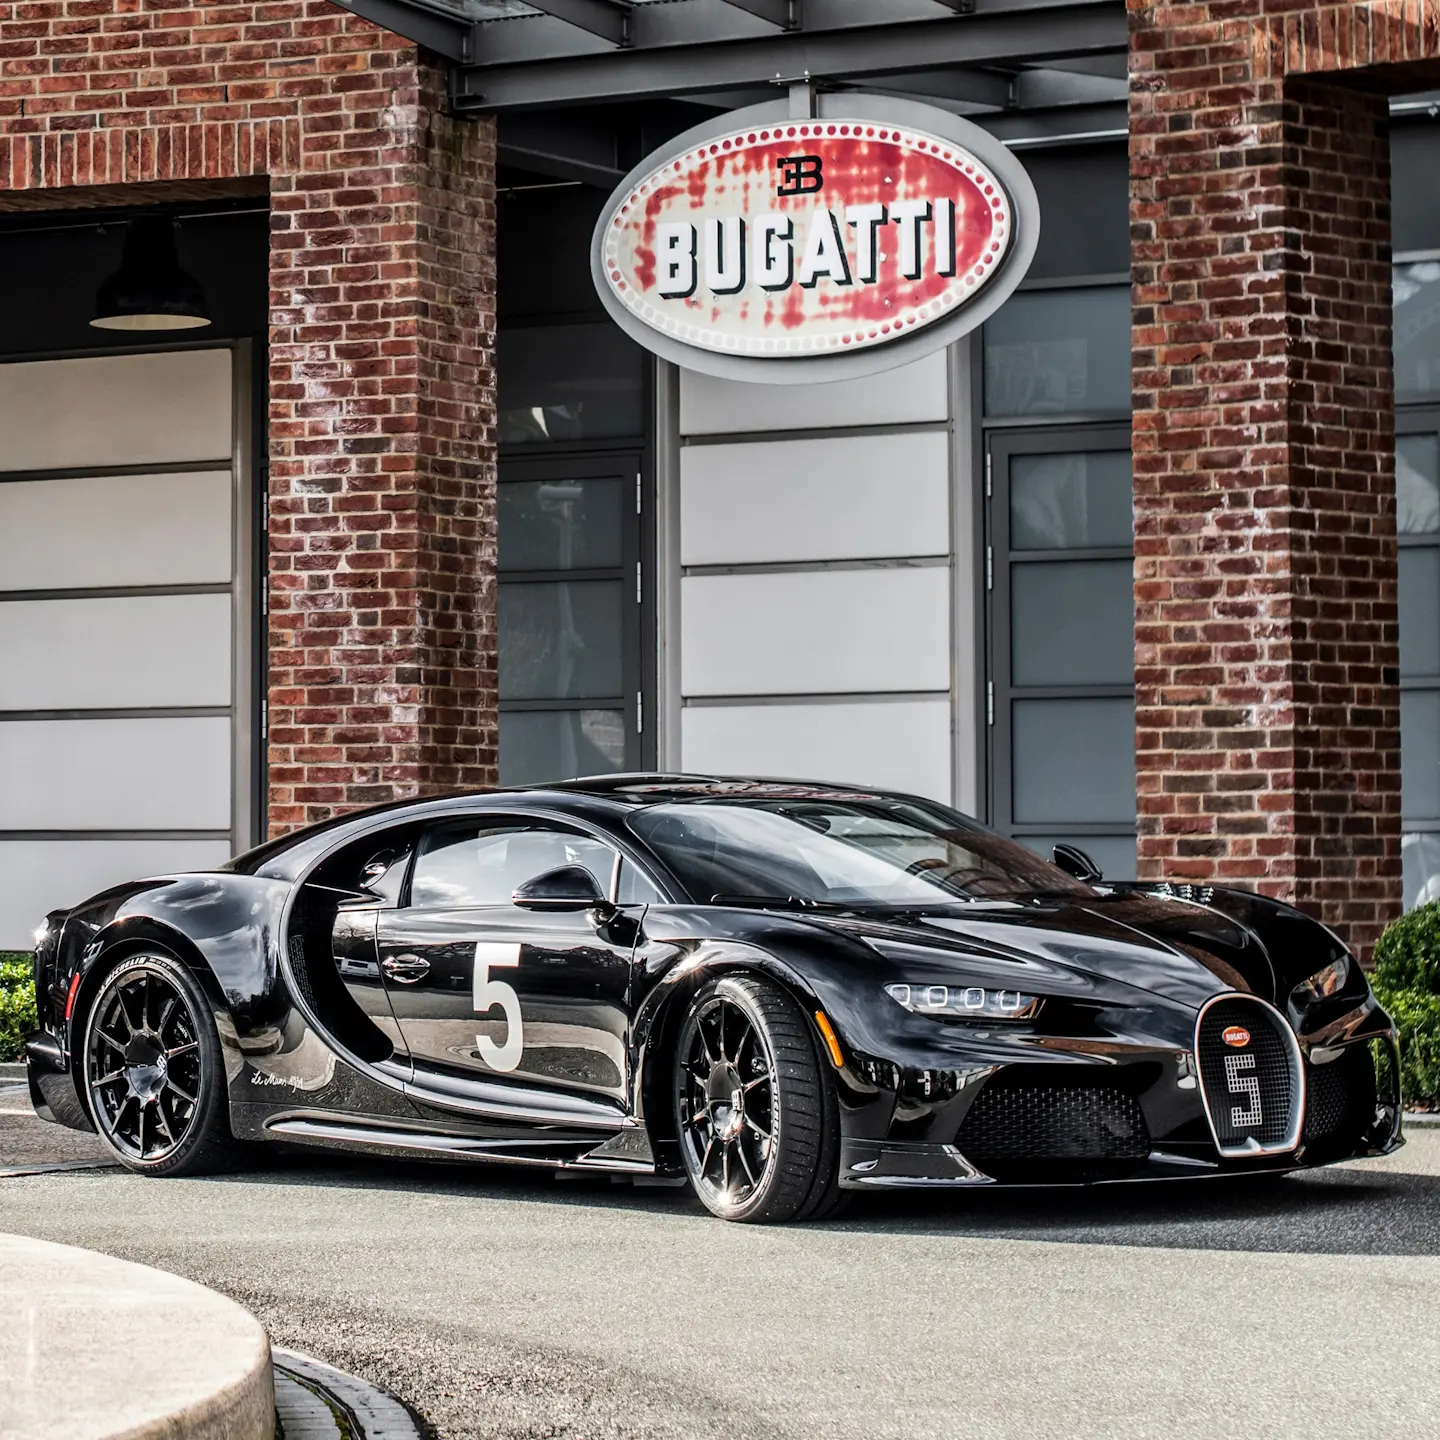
(1130, 11), (1400, 950)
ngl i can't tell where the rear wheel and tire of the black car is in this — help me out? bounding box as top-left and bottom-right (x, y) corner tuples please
(81, 950), (239, 1176)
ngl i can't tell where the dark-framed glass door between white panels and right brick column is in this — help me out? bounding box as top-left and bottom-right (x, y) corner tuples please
(986, 426), (1136, 880)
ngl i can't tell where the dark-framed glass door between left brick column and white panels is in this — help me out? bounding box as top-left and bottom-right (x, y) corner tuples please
(498, 449), (645, 785)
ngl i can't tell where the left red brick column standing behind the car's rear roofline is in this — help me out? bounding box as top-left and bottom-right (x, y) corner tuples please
(269, 63), (497, 832)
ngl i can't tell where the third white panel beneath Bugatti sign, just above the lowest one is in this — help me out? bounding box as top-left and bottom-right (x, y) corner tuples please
(680, 566), (950, 696)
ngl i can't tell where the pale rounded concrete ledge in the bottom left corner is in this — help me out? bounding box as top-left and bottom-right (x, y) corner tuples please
(0, 1236), (275, 1440)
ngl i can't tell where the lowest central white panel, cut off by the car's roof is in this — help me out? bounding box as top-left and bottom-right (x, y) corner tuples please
(681, 696), (952, 804)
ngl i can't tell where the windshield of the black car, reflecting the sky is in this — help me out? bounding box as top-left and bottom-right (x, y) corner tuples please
(629, 798), (1093, 909)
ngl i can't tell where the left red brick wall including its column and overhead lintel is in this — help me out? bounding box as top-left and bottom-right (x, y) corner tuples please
(0, 0), (495, 831)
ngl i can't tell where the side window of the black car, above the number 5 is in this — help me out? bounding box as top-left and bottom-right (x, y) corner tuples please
(410, 824), (616, 910)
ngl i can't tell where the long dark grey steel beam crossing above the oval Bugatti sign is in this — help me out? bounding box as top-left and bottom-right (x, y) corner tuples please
(449, 0), (1126, 109)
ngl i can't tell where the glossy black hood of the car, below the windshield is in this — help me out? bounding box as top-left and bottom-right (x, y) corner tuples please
(821, 893), (1277, 1007)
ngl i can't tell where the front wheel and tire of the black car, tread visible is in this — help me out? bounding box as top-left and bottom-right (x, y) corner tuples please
(672, 975), (840, 1224)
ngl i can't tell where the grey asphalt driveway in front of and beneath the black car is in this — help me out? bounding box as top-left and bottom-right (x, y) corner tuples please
(0, 1083), (1440, 1440)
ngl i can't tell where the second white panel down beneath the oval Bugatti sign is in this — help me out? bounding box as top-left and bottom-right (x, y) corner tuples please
(680, 431), (950, 566)
